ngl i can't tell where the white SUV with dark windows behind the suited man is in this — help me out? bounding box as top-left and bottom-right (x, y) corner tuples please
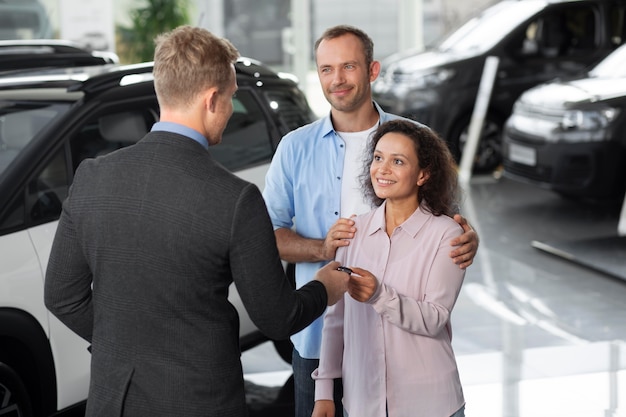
(0, 58), (314, 416)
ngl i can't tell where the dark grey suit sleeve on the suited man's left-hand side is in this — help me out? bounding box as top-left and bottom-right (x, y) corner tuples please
(44, 188), (93, 342)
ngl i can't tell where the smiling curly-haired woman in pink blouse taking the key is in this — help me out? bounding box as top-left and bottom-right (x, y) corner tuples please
(312, 120), (465, 417)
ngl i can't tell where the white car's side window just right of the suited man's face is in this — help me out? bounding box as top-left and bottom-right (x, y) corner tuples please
(209, 89), (273, 172)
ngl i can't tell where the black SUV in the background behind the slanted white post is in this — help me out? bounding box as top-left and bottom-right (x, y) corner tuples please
(372, 0), (626, 171)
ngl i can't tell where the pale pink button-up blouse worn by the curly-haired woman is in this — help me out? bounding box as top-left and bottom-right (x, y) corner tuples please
(312, 203), (465, 417)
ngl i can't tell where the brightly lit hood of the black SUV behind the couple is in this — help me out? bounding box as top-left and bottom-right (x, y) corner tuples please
(382, 49), (476, 74)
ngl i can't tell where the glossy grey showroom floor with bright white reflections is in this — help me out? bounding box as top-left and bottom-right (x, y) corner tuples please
(244, 177), (626, 417)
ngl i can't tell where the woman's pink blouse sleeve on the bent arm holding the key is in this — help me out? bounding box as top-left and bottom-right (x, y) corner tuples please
(369, 225), (465, 337)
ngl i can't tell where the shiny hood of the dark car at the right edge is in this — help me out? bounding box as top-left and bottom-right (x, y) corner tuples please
(520, 78), (626, 108)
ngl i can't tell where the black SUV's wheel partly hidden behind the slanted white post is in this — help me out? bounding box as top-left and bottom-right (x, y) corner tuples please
(449, 114), (503, 173)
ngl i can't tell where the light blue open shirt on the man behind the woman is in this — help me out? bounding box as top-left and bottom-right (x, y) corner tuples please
(263, 103), (412, 359)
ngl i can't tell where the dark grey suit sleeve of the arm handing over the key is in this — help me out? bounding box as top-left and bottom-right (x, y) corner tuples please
(230, 184), (328, 339)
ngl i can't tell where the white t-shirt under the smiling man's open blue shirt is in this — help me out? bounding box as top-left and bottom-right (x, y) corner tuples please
(337, 122), (378, 217)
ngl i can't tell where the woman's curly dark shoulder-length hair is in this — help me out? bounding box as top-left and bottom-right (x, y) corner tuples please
(360, 119), (460, 217)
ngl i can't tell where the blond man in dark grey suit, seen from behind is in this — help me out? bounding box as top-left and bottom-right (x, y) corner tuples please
(45, 26), (349, 417)
